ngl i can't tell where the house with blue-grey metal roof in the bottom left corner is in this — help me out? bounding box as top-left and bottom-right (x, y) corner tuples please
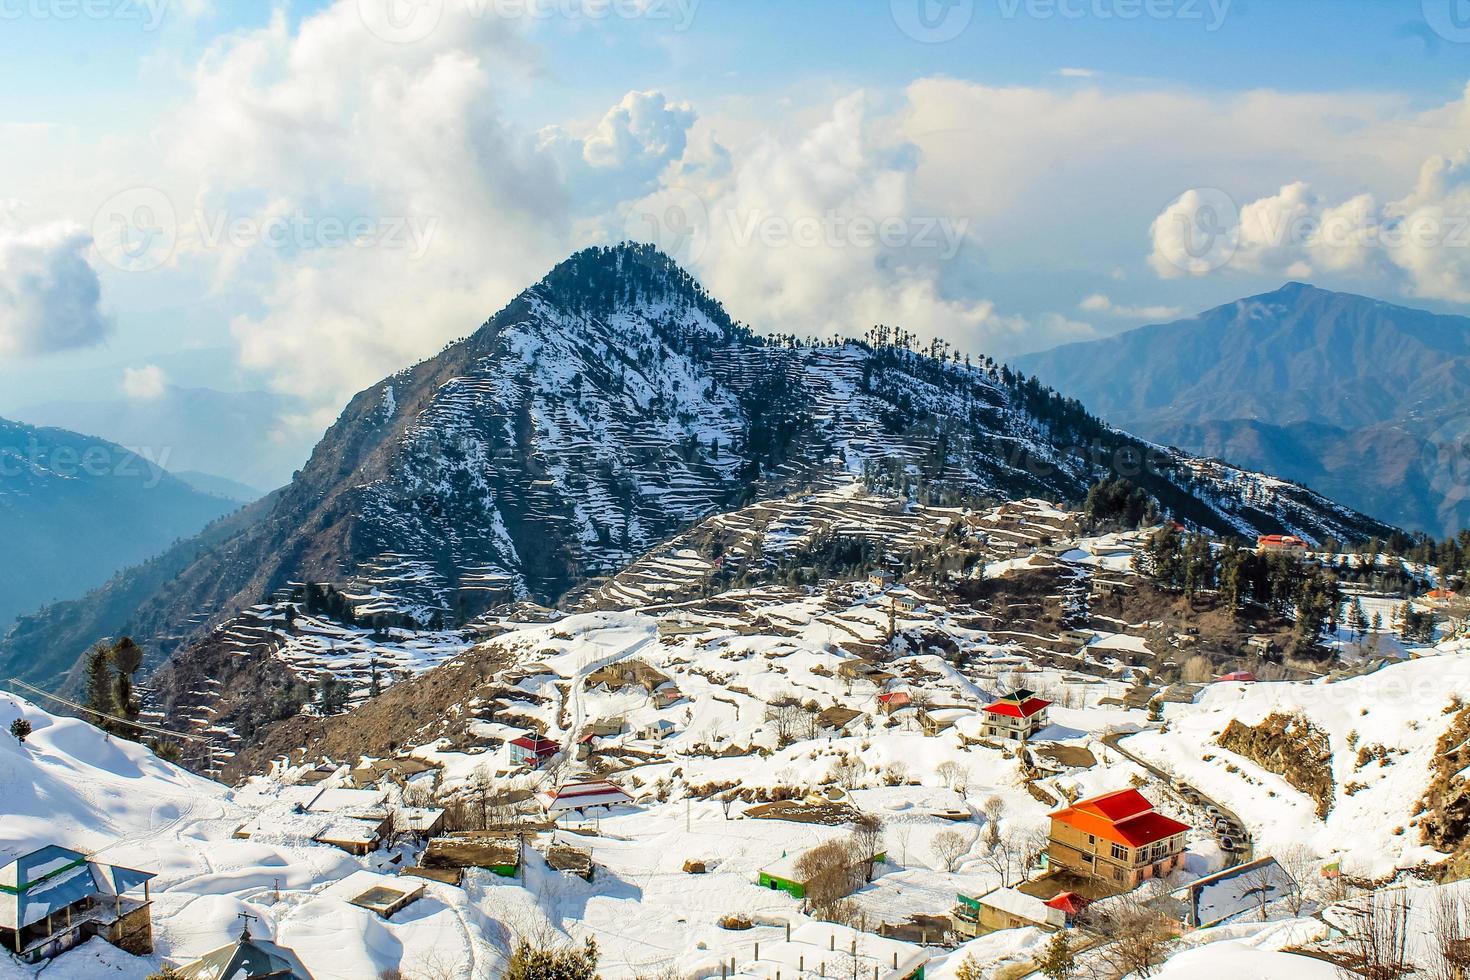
(0, 843), (154, 962)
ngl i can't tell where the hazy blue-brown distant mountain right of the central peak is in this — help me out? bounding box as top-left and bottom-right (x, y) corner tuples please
(1016, 282), (1470, 533)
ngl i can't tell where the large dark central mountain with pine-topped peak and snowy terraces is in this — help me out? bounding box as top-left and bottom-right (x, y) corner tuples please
(0, 245), (1388, 682)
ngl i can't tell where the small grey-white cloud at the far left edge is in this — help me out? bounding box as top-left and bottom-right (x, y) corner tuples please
(0, 215), (112, 356)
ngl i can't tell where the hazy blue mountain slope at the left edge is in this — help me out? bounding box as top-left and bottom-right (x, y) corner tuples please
(0, 419), (238, 635)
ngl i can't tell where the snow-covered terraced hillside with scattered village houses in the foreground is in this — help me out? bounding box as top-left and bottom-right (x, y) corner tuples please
(0, 483), (1470, 980)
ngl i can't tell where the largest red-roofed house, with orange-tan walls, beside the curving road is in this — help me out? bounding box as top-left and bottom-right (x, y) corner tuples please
(1047, 789), (1189, 892)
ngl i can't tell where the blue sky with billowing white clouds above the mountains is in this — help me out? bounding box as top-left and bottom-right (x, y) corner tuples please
(0, 0), (1470, 470)
